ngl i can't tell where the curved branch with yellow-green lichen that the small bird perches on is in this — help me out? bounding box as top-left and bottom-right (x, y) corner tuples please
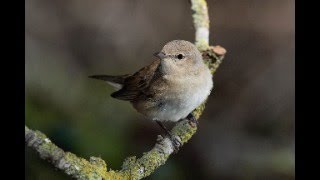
(25, 0), (226, 180)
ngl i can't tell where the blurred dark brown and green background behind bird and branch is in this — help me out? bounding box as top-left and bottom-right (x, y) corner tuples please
(25, 0), (295, 180)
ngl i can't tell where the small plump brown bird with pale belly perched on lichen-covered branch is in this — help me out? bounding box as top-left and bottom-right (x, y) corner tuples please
(89, 40), (213, 150)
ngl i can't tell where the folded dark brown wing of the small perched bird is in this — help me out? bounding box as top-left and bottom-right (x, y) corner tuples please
(111, 60), (160, 101)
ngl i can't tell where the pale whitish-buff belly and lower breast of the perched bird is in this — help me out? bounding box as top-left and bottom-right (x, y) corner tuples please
(133, 71), (213, 122)
